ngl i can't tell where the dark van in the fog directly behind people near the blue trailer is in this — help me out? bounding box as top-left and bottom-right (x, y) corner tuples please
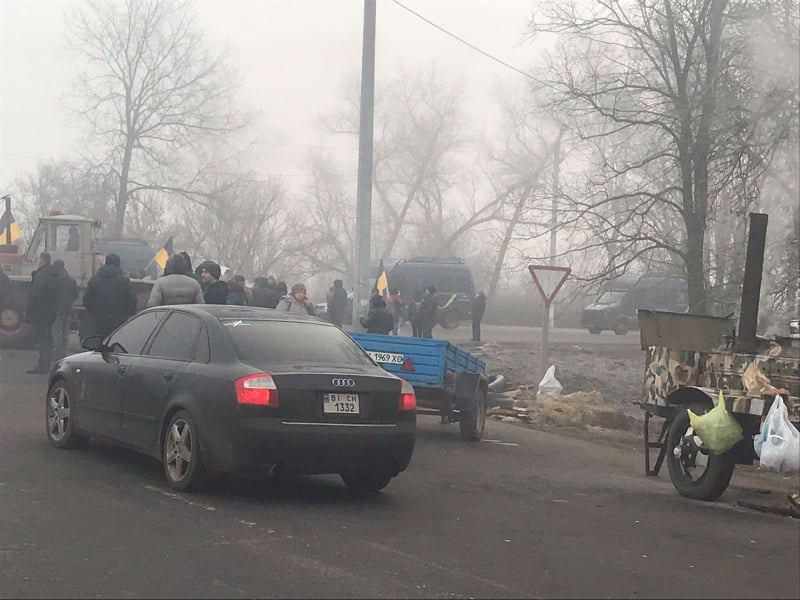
(389, 257), (475, 329)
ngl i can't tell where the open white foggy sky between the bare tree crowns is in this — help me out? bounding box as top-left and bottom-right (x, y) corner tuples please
(0, 0), (535, 191)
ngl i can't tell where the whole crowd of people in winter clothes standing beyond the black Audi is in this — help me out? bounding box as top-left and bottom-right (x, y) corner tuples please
(18, 246), (486, 373)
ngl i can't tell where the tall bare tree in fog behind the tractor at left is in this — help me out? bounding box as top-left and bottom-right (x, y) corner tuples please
(71, 0), (241, 236)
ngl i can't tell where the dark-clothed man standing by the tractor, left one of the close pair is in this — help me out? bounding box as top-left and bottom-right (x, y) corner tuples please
(26, 252), (59, 374)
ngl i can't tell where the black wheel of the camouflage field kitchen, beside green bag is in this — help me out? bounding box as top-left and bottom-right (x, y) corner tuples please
(667, 406), (736, 502)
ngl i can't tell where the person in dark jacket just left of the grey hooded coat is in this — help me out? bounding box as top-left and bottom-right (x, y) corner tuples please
(83, 254), (136, 337)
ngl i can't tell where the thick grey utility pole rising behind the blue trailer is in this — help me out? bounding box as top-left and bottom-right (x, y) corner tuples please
(353, 0), (376, 328)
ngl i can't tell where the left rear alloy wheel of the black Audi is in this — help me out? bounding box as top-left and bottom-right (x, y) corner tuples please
(161, 410), (206, 492)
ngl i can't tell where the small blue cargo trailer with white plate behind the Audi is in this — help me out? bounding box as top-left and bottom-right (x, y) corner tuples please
(351, 333), (489, 441)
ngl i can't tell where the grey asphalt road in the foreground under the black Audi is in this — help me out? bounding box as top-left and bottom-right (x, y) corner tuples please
(0, 352), (800, 598)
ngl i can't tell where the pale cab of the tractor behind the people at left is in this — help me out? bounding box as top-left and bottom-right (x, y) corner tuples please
(21, 215), (100, 287)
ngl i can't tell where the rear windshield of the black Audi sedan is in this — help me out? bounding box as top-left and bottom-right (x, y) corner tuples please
(222, 319), (372, 367)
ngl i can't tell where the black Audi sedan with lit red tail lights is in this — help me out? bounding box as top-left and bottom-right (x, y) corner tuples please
(46, 305), (416, 494)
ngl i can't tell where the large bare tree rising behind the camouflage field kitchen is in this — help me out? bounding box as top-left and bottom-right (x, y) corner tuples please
(531, 0), (786, 312)
